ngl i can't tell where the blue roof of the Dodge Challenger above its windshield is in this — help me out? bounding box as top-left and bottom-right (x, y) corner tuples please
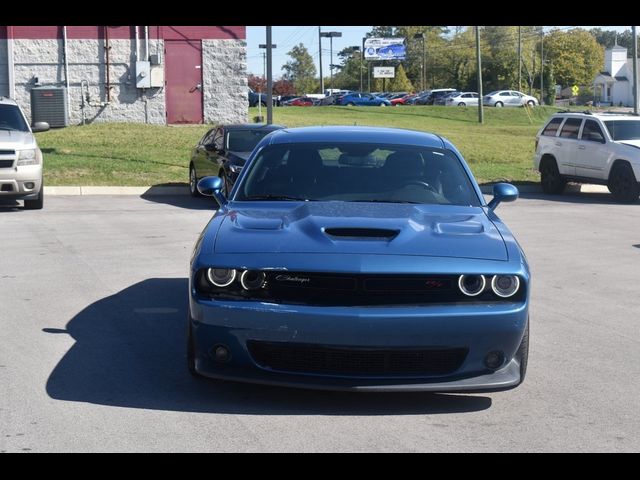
(269, 125), (445, 148)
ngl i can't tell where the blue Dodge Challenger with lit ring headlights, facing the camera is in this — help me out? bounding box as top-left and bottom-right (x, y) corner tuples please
(187, 127), (530, 392)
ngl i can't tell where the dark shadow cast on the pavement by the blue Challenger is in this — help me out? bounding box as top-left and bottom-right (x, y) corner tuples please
(43, 278), (491, 415)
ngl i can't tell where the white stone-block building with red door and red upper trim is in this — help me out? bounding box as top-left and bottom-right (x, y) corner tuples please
(0, 26), (248, 124)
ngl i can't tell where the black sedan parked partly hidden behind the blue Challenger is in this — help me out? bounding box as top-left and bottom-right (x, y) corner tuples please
(189, 123), (284, 197)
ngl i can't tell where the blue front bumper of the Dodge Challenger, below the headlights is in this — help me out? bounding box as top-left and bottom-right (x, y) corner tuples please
(189, 292), (528, 392)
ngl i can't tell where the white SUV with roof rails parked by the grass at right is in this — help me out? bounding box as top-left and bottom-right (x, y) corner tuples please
(533, 112), (640, 203)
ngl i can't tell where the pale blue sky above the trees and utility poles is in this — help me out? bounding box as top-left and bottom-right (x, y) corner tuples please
(247, 25), (631, 79)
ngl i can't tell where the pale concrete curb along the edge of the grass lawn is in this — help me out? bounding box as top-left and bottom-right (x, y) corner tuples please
(44, 184), (609, 197)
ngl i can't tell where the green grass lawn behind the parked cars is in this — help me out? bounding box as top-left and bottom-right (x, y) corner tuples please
(37, 106), (557, 185)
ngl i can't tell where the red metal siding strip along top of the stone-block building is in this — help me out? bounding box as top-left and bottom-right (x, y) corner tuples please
(0, 25), (247, 40)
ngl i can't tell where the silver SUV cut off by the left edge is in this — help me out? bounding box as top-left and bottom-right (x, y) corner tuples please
(0, 97), (49, 210)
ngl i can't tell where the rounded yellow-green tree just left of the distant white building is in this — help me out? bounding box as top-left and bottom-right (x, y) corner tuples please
(544, 28), (604, 86)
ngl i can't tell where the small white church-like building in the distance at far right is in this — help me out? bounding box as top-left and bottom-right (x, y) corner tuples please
(593, 45), (633, 107)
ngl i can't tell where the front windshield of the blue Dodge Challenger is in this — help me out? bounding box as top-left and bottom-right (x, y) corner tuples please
(234, 143), (480, 206)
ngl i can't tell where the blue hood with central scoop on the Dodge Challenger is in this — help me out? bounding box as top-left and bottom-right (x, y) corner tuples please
(214, 202), (508, 261)
